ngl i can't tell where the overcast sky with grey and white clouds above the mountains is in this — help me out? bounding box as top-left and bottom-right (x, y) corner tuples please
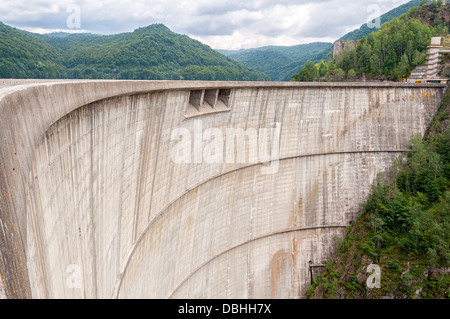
(0, 0), (414, 49)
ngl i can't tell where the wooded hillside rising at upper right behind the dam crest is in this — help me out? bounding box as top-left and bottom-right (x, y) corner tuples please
(291, 1), (450, 81)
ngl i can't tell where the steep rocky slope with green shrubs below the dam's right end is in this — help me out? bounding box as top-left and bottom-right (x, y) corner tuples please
(308, 90), (450, 299)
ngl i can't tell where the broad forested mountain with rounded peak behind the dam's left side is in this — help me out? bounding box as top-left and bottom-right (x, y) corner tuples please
(0, 24), (269, 81)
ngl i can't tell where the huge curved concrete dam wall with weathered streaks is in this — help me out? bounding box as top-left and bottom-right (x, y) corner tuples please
(0, 81), (446, 299)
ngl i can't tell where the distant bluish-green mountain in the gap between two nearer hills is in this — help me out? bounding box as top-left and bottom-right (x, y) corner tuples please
(218, 42), (332, 81)
